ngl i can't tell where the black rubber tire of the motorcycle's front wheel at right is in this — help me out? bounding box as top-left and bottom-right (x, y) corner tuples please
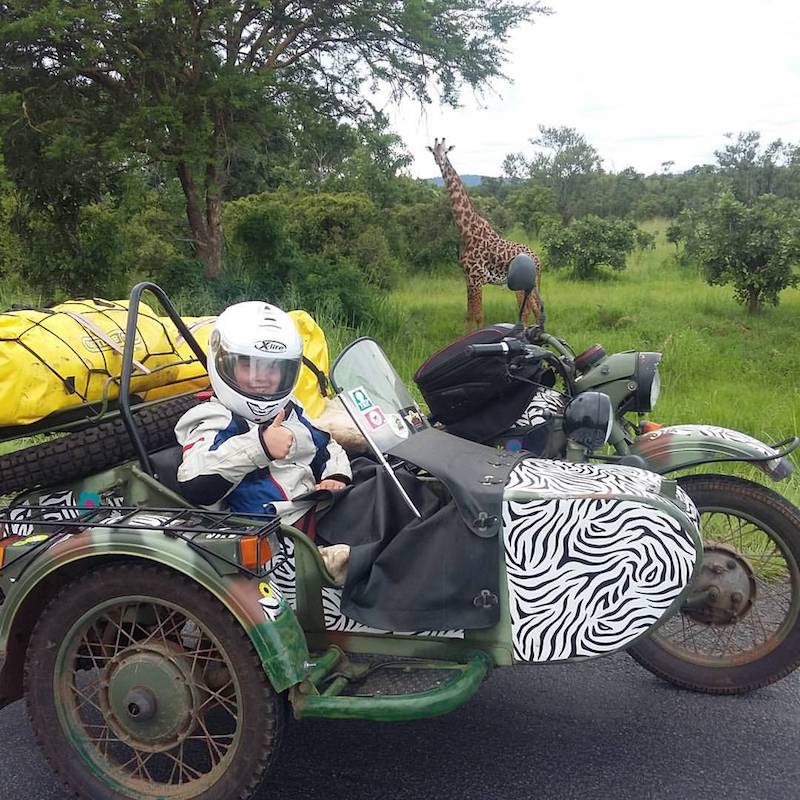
(628, 475), (800, 694)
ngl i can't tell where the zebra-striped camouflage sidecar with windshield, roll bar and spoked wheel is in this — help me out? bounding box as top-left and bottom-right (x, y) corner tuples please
(0, 284), (702, 800)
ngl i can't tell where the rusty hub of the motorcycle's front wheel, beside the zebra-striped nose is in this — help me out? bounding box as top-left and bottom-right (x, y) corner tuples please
(684, 544), (756, 625)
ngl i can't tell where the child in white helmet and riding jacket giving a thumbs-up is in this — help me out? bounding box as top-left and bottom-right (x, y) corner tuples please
(175, 301), (352, 580)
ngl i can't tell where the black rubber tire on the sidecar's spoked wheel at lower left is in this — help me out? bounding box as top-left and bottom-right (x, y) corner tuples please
(25, 564), (286, 800)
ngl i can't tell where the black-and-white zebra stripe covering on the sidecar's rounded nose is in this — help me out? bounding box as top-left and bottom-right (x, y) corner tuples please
(503, 459), (697, 662)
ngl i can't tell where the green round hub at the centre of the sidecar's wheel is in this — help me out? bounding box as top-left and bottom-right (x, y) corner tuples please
(100, 644), (198, 752)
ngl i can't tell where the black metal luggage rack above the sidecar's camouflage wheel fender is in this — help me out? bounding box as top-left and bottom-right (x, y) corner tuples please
(0, 505), (286, 578)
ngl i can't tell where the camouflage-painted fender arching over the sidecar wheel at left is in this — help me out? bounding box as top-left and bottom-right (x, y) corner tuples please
(0, 528), (309, 692)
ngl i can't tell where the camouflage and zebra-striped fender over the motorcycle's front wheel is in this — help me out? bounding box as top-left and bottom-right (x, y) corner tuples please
(631, 425), (792, 481)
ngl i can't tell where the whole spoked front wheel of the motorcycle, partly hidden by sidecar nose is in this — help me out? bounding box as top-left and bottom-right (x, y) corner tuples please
(628, 475), (800, 694)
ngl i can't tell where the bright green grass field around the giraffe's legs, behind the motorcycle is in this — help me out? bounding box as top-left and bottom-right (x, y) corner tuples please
(350, 221), (800, 503)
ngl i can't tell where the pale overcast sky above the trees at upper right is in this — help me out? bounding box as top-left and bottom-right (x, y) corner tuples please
(385, 0), (800, 177)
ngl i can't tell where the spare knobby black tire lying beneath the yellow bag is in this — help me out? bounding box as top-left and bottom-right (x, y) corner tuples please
(0, 396), (199, 494)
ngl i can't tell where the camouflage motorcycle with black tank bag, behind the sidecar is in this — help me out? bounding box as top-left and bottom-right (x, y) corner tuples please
(415, 256), (800, 694)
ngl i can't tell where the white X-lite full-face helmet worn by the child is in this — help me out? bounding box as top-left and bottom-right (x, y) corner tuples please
(208, 301), (303, 423)
